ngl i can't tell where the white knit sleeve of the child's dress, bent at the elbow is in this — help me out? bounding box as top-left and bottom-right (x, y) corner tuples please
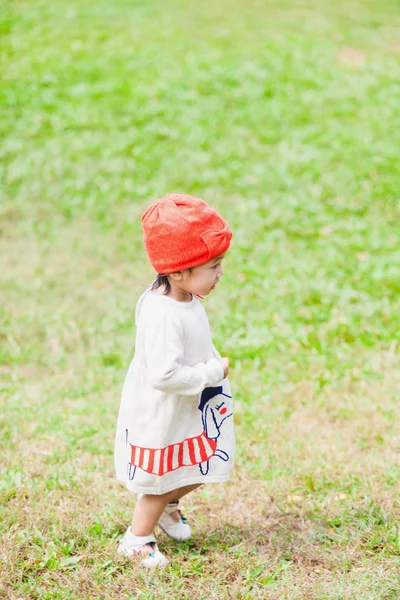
(143, 314), (224, 396)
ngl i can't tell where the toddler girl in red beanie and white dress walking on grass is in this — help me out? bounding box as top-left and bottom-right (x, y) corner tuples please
(115, 194), (235, 567)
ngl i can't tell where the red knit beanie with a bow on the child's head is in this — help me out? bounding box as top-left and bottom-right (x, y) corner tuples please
(142, 194), (232, 275)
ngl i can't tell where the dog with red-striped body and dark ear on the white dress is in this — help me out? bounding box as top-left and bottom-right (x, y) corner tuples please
(126, 385), (233, 480)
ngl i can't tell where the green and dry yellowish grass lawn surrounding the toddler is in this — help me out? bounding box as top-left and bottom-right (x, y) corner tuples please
(0, 0), (400, 600)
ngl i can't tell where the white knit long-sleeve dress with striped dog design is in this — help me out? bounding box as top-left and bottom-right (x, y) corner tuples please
(114, 290), (235, 494)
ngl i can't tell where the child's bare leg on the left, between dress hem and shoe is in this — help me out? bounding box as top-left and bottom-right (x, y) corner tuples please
(131, 485), (199, 536)
